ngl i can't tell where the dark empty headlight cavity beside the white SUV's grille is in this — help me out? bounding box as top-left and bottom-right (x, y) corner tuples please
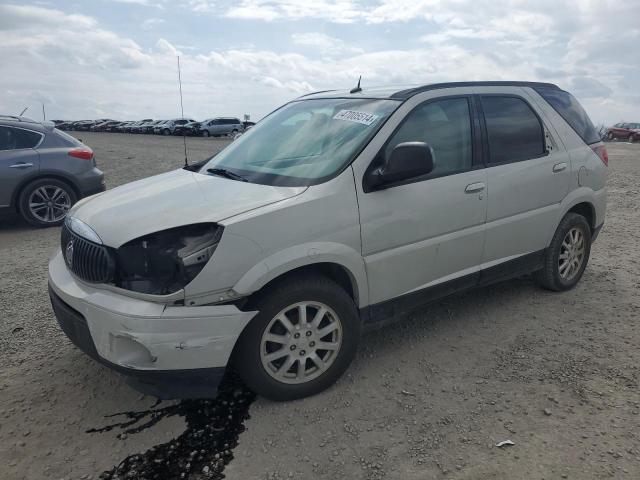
(115, 223), (223, 295)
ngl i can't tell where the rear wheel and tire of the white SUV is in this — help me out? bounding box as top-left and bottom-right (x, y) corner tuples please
(534, 213), (591, 292)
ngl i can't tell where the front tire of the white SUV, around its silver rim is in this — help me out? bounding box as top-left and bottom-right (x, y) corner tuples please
(233, 275), (360, 401)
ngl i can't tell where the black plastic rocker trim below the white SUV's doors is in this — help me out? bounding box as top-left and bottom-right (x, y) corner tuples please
(360, 249), (546, 330)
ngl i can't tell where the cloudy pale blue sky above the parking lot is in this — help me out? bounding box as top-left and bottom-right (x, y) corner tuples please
(0, 0), (640, 124)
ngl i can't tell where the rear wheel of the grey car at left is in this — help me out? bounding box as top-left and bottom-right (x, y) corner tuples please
(18, 178), (78, 227)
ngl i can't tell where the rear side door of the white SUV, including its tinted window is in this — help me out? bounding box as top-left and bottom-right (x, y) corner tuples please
(477, 87), (571, 274)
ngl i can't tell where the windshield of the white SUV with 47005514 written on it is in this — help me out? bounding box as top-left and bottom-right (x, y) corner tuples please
(201, 98), (399, 186)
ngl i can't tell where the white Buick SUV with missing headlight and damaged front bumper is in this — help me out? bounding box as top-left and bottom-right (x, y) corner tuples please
(49, 82), (607, 400)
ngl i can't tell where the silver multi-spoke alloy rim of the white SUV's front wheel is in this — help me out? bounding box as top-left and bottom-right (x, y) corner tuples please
(260, 302), (343, 384)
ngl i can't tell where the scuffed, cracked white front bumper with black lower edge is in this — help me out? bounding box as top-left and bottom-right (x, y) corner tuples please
(49, 251), (257, 399)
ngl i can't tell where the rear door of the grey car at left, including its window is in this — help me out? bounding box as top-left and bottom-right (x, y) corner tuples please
(0, 126), (44, 207)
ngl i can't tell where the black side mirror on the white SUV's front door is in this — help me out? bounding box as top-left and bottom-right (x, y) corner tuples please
(368, 142), (433, 190)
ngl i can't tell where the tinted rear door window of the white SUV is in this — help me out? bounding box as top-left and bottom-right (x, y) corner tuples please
(482, 96), (545, 163)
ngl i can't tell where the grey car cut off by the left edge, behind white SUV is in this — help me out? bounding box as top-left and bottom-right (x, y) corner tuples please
(0, 116), (105, 227)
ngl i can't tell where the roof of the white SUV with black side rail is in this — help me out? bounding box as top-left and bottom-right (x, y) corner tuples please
(299, 81), (559, 100)
